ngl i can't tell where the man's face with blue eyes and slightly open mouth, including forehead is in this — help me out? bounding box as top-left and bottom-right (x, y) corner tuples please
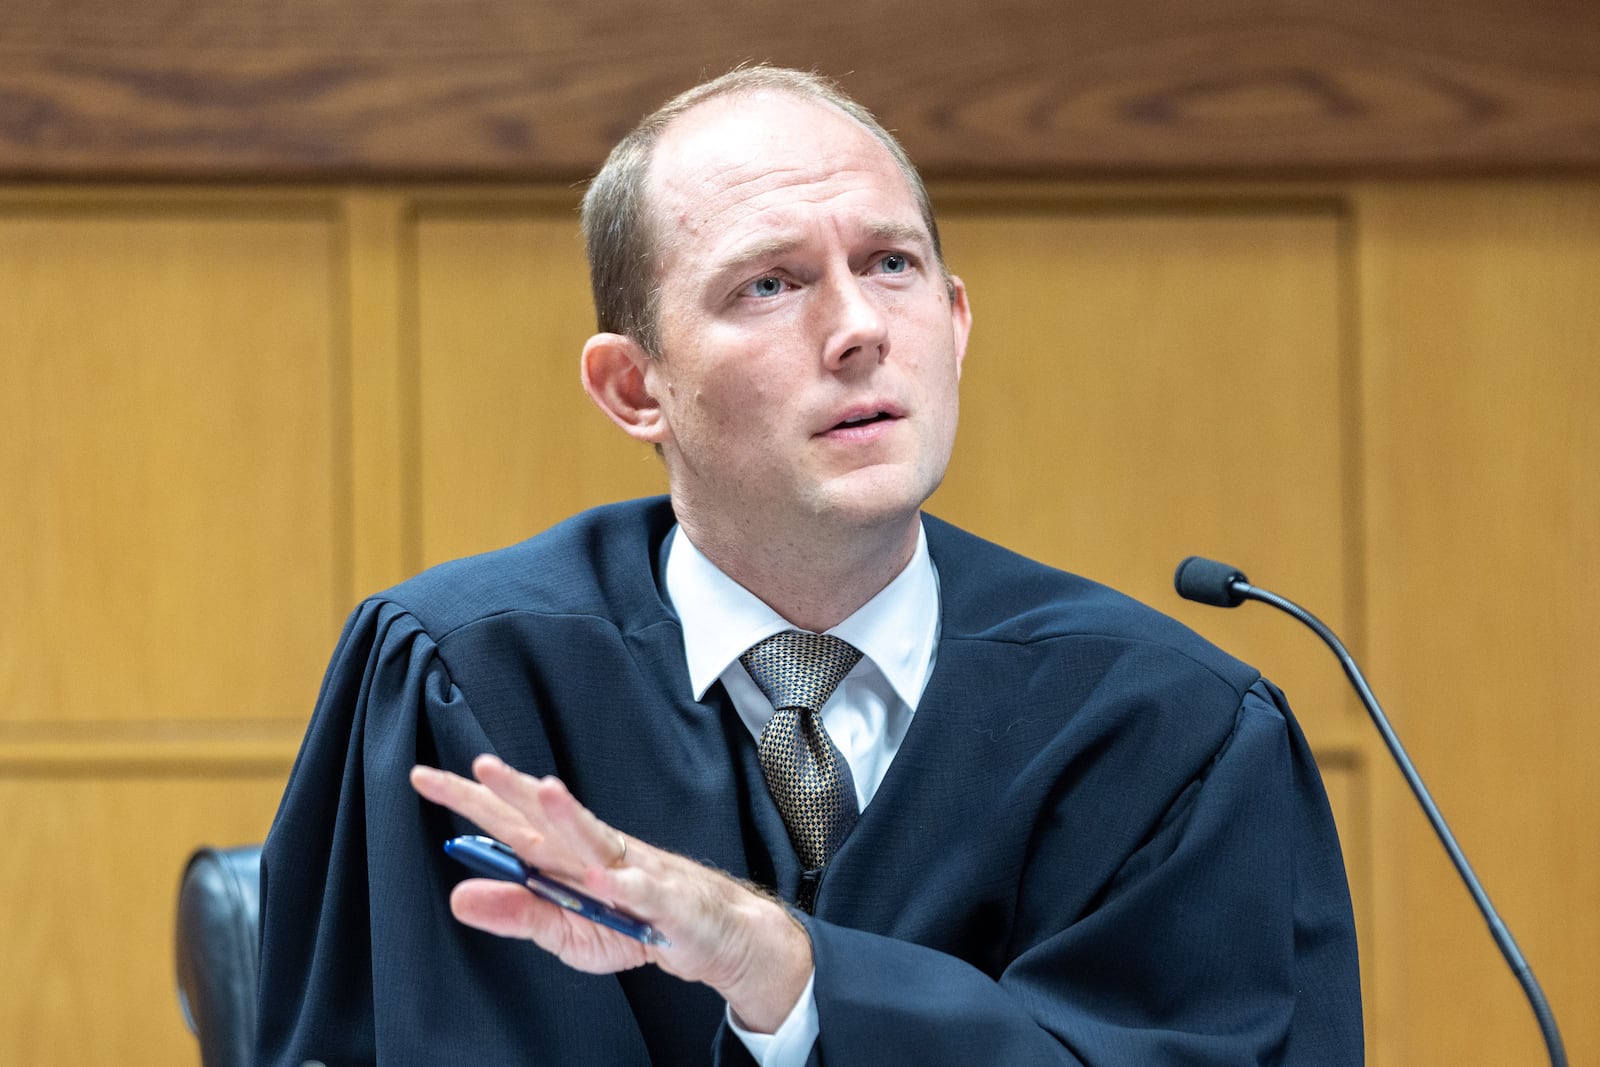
(645, 93), (971, 550)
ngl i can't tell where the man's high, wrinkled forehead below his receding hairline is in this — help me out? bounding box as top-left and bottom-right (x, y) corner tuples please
(646, 91), (926, 259)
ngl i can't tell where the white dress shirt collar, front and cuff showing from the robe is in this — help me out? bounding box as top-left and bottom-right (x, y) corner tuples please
(666, 525), (939, 1067)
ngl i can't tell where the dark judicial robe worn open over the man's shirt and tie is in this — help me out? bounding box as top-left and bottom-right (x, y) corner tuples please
(258, 499), (1362, 1067)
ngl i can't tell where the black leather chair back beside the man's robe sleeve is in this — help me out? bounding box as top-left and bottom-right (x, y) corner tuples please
(178, 845), (261, 1067)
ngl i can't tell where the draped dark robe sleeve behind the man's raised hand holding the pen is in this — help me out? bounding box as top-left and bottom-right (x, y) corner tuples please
(256, 600), (648, 1067)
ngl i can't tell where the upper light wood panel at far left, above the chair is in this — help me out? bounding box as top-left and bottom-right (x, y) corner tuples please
(0, 198), (349, 721)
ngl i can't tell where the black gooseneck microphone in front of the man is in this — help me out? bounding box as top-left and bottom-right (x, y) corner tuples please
(1173, 555), (1566, 1067)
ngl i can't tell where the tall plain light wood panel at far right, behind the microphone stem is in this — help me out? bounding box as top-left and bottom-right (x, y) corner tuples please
(1358, 182), (1600, 1064)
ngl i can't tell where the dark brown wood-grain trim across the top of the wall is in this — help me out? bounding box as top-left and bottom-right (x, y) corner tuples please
(0, 0), (1600, 181)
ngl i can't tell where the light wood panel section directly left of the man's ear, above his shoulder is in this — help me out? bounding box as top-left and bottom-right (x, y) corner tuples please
(414, 198), (666, 563)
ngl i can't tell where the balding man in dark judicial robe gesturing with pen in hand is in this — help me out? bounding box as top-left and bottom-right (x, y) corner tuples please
(259, 67), (1362, 1067)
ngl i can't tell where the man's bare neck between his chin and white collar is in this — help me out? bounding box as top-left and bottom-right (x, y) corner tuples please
(678, 514), (920, 632)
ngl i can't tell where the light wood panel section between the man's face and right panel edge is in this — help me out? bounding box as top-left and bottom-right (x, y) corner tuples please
(930, 198), (1357, 741)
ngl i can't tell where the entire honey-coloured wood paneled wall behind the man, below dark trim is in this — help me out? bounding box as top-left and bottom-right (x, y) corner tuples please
(0, 181), (1600, 1067)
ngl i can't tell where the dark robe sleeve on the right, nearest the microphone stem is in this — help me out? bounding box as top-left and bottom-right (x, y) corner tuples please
(748, 681), (1362, 1067)
